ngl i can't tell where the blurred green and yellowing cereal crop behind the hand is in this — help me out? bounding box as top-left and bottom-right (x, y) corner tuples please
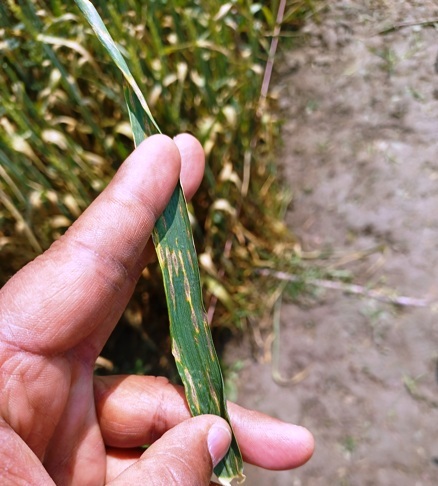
(0, 0), (312, 375)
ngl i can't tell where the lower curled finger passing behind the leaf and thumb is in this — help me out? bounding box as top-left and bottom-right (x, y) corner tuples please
(95, 376), (314, 470)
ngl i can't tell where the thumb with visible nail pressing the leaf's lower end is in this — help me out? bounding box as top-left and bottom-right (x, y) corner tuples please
(109, 415), (231, 486)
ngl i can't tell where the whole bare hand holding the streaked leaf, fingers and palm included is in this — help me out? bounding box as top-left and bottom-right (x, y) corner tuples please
(0, 135), (314, 486)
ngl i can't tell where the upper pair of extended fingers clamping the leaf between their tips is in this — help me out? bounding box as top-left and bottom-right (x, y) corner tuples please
(0, 135), (204, 360)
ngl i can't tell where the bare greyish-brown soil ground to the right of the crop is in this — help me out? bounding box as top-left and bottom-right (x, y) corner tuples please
(227, 0), (438, 486)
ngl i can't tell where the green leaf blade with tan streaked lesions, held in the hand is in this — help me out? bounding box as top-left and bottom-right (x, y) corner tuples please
(75, 0), (244, 485)
